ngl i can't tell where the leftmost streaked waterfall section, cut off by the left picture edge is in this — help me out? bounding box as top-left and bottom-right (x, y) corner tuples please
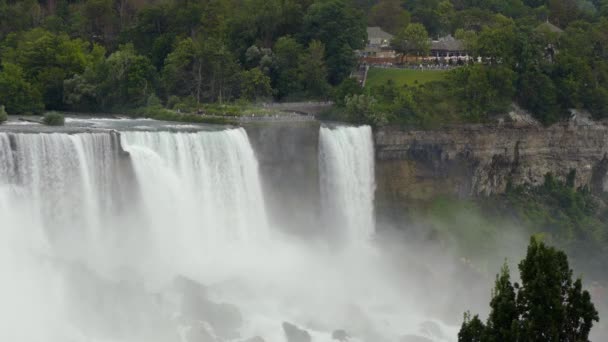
(0, 133), (122, 253)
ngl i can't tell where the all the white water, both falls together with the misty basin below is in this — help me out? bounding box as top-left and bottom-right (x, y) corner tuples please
(0, 120), (455, 342)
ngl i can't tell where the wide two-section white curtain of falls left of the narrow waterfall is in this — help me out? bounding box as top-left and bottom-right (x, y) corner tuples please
(0, 129), (269, 259)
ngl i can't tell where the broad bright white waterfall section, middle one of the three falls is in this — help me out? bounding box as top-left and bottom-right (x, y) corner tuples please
(122, 129), (269, 258)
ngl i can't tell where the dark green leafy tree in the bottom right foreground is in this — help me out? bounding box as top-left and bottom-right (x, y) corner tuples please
(458, 237), (599, 342)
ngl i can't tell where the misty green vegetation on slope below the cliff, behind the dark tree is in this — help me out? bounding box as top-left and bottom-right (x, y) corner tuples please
(423, 172), (608, 283)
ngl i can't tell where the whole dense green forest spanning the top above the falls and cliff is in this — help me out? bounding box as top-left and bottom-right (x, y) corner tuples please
(0, 0), (608, 125)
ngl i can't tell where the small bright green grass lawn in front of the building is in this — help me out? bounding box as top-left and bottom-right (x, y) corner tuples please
(365, 68), (447, 88)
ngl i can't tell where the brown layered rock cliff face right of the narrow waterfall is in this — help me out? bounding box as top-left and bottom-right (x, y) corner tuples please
(375, 122), (608, 210)
